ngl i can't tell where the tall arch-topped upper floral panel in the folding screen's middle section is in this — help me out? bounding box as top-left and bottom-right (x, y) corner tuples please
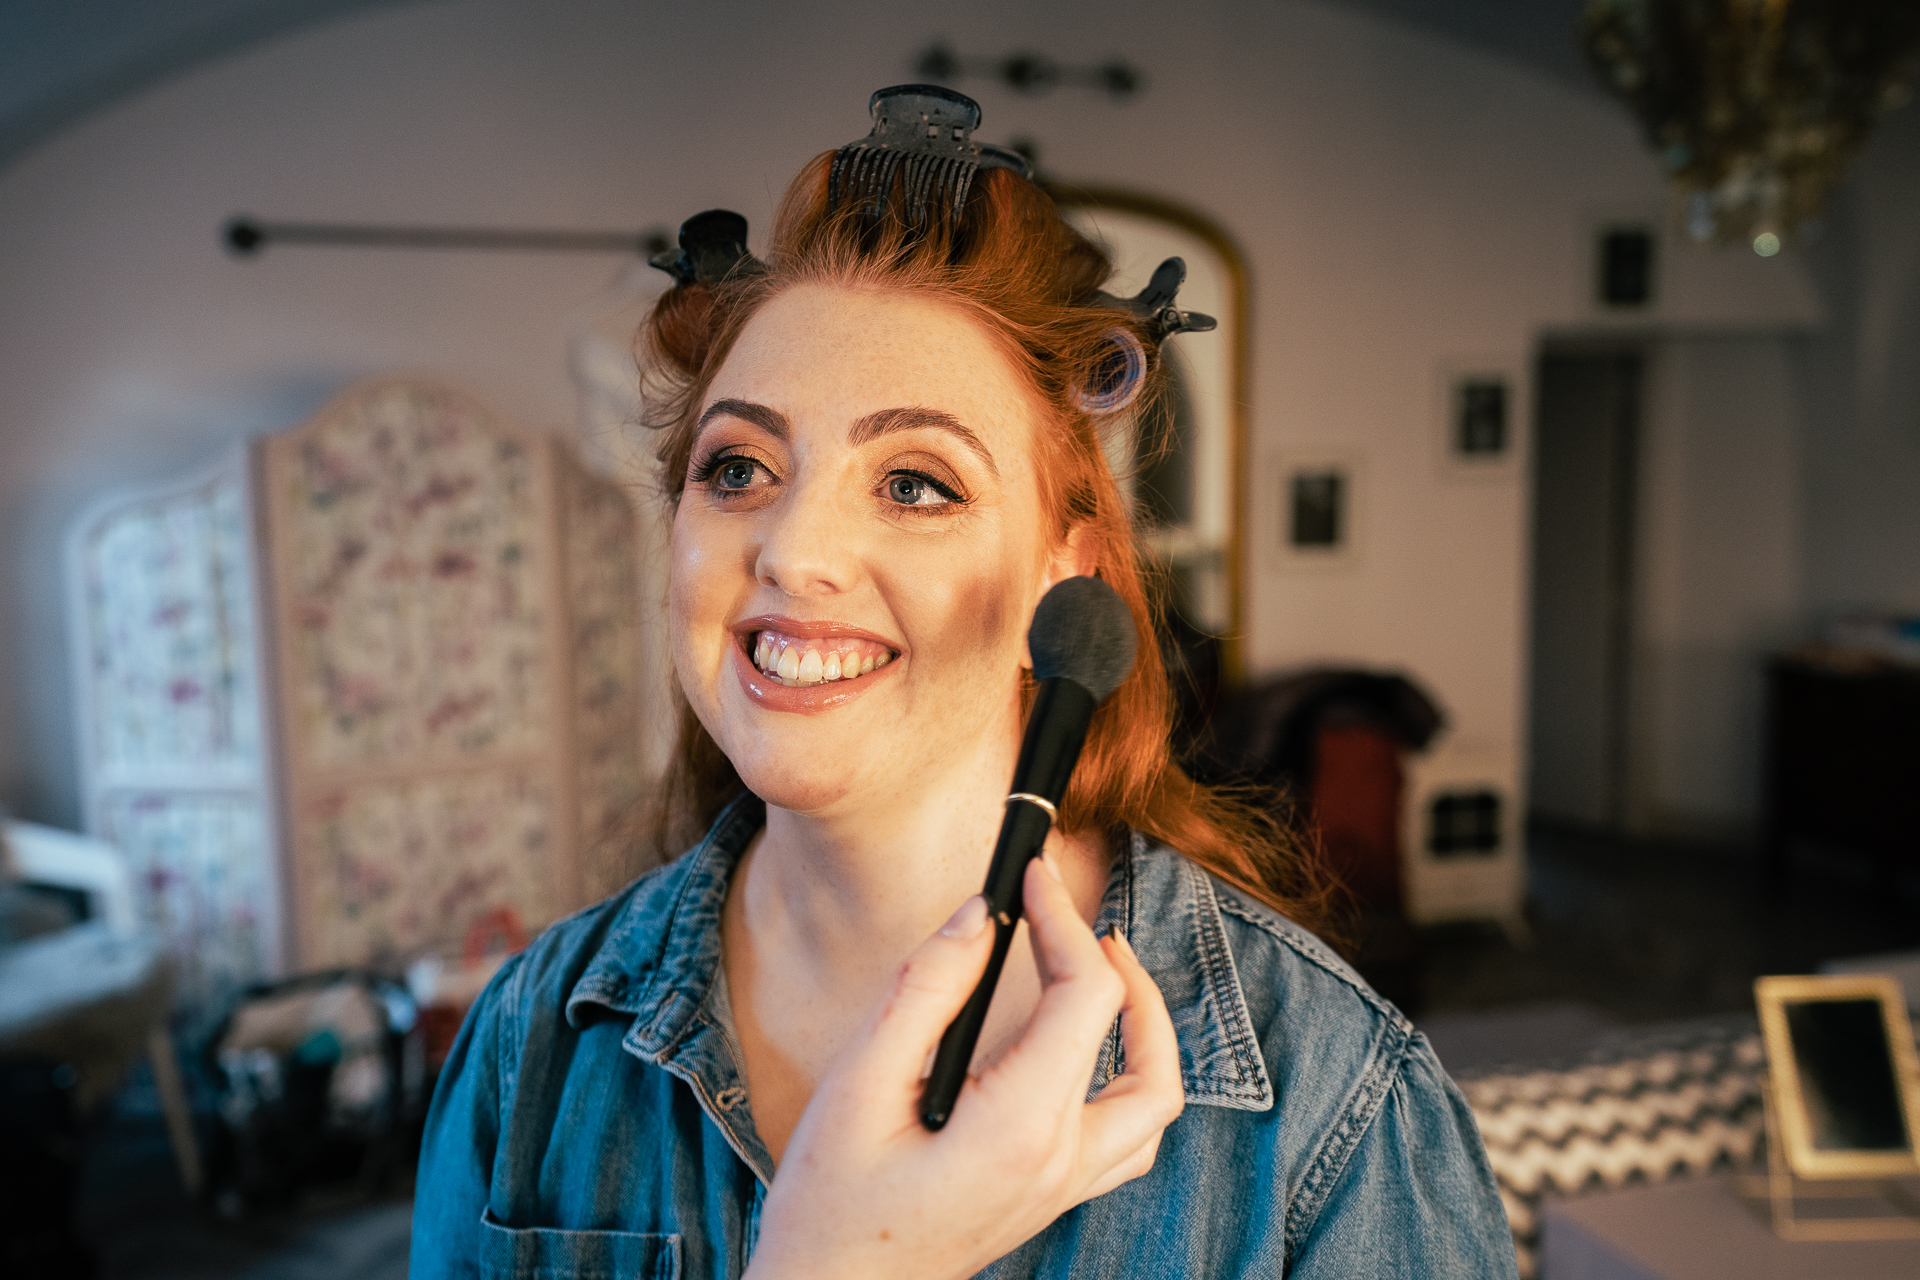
(269, 384), (551, 768)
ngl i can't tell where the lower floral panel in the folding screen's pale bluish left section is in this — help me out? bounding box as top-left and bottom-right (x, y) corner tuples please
(98, 791), (275, 1019)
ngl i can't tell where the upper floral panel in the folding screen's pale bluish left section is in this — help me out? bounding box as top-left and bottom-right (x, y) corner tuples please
(79, 476), (261, 777)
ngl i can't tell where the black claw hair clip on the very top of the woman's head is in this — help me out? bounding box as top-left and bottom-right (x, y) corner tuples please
(828, 84), (1033, 226)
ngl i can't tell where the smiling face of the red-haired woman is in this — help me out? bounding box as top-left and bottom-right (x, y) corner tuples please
(672, 284), (1077, 812)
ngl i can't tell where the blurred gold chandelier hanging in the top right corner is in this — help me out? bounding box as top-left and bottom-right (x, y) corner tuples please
(1580, 0), (1920, 257)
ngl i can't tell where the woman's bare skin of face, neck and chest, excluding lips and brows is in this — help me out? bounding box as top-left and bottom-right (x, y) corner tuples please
(670, 284), (1110, 1161)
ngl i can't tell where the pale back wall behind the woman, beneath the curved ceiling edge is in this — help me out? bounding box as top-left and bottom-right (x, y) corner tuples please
(0, 0), (1843, 836)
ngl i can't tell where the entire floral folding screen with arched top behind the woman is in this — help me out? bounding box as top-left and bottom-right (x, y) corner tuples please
(73, 382), (641, 1006)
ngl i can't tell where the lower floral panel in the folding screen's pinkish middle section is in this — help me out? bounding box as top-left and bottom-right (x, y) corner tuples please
(294, 768), (561, 967)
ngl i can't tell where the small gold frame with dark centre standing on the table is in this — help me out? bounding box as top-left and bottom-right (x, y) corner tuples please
(1753, 973), (1920, 1178)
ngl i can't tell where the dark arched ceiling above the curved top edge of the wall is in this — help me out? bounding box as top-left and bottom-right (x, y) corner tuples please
(0, 0), (1594, 167)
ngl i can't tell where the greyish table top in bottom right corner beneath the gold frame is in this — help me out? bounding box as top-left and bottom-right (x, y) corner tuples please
(1540, 1176), (1920, 1280)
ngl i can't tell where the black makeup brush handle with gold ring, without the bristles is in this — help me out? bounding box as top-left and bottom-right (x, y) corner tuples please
(920, 676), (1098, 1130)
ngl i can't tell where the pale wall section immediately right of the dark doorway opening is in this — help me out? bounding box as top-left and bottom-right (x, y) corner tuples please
(1628, 334), (1809, 841)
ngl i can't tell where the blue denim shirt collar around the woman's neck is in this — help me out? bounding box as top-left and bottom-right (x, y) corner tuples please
(566, 794), (1273, 1180)
